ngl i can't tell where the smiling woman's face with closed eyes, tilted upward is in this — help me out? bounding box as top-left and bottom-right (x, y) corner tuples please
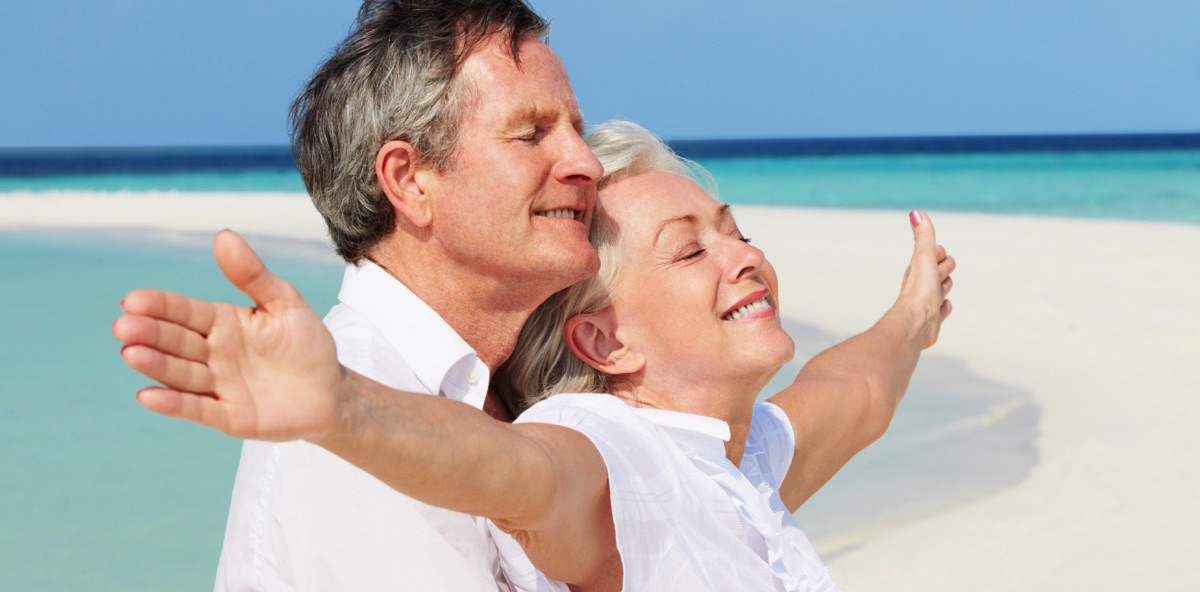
(600, 172), (794, 389)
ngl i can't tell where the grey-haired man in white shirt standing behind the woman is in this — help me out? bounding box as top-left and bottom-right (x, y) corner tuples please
(204, 0), (601, 591)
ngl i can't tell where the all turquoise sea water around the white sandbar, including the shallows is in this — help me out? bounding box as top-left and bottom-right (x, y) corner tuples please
(0, 137), (1200, 591)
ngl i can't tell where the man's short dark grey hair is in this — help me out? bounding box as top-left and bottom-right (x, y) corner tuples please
(289, 0), (548, 262)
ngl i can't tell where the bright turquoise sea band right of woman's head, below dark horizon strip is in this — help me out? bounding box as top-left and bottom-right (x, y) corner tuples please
(703, 150), (1200, 223)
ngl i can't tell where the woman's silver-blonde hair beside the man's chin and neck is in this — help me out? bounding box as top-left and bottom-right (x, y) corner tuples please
(492, 120), (716, 417)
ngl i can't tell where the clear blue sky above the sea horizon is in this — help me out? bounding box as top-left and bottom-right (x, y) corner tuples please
(0, 0), (1200, 146)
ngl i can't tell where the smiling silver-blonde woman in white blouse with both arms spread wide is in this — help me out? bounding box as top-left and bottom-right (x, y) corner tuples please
(117, 122), (954, 591)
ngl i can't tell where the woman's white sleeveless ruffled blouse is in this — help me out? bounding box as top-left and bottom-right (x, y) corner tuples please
(498, 394), (838, 592)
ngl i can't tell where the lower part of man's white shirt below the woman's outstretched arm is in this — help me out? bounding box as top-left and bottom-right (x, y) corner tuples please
(217, 442), (504, 591)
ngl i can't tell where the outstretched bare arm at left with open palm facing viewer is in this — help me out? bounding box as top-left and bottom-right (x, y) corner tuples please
(113, 231), (616, 584)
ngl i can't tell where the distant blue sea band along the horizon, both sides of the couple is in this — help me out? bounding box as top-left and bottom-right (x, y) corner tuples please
(0, 134), (1200, 223)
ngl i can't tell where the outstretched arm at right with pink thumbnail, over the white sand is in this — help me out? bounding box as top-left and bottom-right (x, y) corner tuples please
(769, 210), (955, 512)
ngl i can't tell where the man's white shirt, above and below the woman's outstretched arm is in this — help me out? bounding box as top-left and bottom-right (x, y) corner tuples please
(216, 261), (508, 592)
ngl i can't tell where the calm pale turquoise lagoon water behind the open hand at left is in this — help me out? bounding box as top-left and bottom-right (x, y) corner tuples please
(0, 233), (341, 591)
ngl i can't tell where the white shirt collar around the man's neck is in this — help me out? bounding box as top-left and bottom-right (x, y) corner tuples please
(337, 259), (490, 408)
